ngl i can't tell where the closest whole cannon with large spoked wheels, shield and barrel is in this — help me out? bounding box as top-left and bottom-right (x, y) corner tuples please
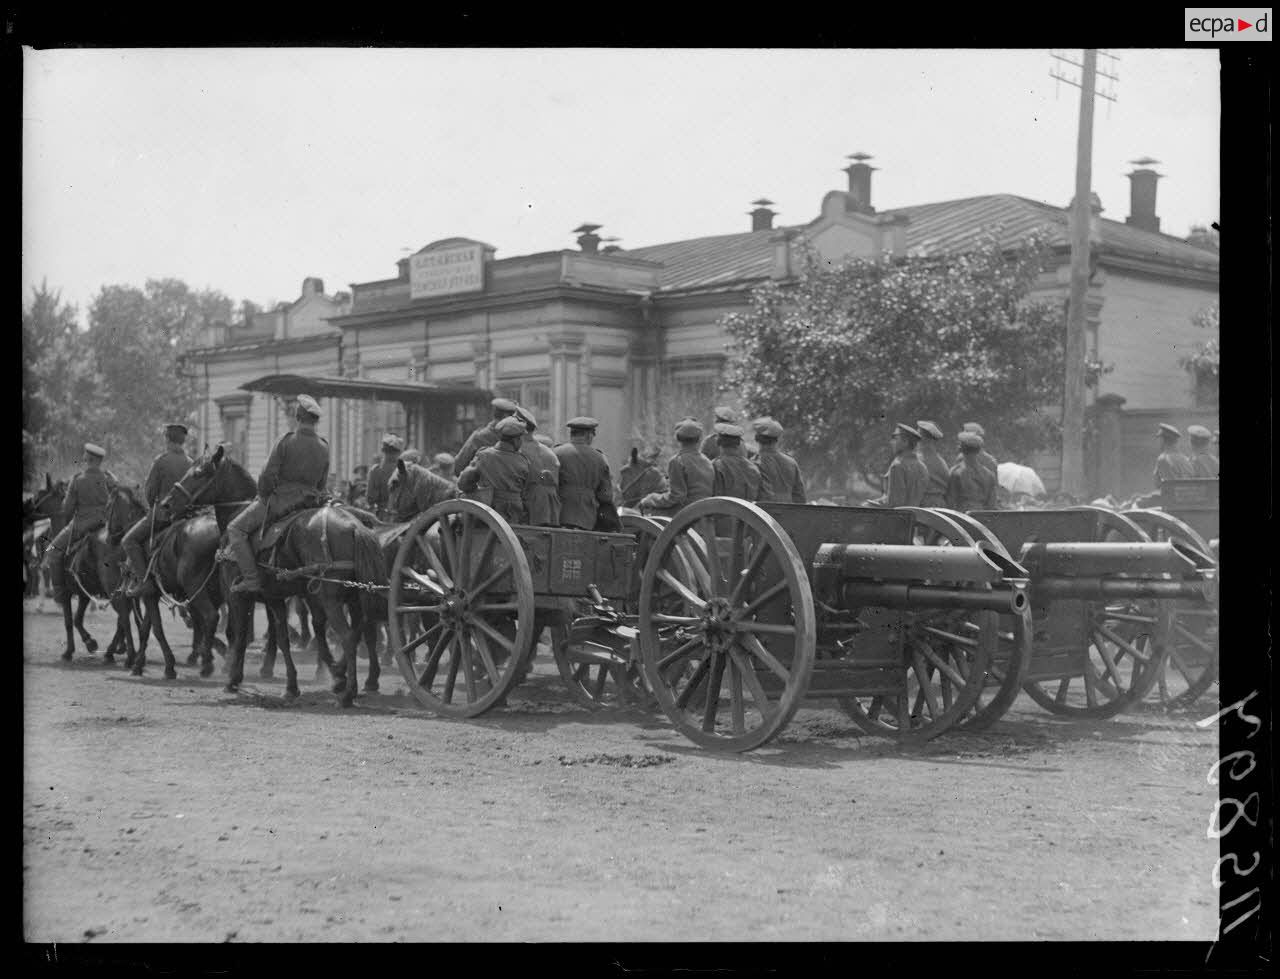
(639, 498), (1029, 751)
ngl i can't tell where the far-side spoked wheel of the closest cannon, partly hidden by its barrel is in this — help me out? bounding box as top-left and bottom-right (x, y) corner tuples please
(840, 507), (1021, 742)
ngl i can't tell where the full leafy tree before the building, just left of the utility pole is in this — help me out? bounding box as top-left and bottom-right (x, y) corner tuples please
(723, 233), (1065, 488)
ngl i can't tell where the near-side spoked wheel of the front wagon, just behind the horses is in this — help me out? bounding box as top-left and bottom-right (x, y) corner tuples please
(388, 499), (535, 717)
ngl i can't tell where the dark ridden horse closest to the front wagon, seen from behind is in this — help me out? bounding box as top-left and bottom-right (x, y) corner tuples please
(158, 445), (387, 706)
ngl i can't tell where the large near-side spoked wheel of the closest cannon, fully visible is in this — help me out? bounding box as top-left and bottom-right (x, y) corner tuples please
(640, 497), (817, 751)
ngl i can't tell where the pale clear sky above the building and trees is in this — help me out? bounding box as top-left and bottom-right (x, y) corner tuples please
(22, 49), (1220, 322)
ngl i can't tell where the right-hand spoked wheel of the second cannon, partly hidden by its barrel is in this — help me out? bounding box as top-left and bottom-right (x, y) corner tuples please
(1023, 507), (1172, 719)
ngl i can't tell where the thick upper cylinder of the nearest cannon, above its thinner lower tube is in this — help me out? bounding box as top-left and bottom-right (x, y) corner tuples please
(813, 541), (1029, 585)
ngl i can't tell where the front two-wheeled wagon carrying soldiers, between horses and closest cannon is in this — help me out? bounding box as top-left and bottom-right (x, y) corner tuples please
(388, 499), (659, 717)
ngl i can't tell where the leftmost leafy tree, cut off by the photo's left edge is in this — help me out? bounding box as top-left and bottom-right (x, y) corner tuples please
(22, 282), (97, 481)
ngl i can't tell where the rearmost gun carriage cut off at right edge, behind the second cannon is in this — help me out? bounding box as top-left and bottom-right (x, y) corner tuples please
(1125, 479), (1219, 708)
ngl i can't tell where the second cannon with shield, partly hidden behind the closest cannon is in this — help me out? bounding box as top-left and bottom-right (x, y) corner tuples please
(950, 507), (1216, 728)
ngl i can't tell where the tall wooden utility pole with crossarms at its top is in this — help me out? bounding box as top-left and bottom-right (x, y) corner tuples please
(1050, 49), (1115, 497)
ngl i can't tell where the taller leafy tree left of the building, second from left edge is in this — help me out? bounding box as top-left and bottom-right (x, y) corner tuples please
(88, 279), (234, 479)
